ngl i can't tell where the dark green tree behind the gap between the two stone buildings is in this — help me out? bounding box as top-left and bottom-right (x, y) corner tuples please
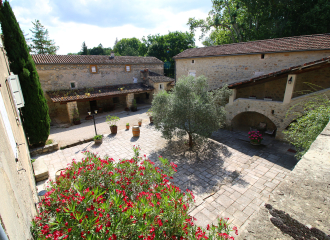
(142, 31), (195, 77)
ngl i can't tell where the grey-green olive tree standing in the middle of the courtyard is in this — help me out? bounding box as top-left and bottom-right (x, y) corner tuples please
(152, 76), (231, 147)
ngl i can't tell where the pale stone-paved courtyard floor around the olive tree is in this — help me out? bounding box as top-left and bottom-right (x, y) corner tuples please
(37, 124), (296, 237)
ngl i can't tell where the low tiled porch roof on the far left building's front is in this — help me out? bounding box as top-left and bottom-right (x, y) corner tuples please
(47, 83), (154, 103)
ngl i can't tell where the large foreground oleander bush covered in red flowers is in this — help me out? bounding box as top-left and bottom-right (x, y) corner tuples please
(32, 147), (237, 240)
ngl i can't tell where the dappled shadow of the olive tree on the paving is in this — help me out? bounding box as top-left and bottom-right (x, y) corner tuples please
(149, 140), (248, 200)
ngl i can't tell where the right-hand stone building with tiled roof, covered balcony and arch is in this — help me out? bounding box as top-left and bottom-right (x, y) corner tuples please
(174, 34), (330, 139)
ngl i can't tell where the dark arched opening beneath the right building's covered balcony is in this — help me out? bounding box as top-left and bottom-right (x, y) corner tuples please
(231, 111), (279, 131)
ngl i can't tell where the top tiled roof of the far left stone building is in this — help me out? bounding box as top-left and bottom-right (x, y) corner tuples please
(31, 54), (164, 64)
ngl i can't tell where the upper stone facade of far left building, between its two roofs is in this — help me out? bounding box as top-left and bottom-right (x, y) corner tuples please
(36, 64), (164, 92)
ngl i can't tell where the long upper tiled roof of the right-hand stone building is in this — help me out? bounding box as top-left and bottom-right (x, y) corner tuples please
(173, 33), (330, 59)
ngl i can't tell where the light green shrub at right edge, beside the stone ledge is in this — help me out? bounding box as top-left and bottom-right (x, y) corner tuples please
(283, 91), (330, 159)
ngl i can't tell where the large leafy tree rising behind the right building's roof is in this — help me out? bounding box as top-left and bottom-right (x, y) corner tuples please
(188, 0), (330, 46)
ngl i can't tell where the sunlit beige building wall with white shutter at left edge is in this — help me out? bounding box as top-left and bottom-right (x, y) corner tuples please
(0, 40), (38, 239)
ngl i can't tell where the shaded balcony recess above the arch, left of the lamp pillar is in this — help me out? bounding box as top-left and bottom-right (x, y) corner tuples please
(236, 77), (287, 101)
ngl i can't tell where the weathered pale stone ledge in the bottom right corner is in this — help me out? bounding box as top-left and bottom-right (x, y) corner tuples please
(238, 123), (330, 240)
